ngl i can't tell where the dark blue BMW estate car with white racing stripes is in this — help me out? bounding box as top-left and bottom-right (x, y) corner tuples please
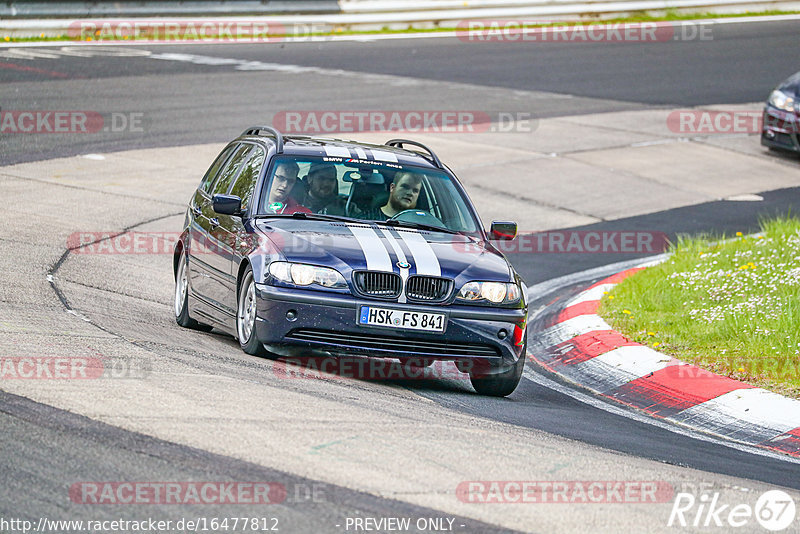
(173, 126), (528, 396)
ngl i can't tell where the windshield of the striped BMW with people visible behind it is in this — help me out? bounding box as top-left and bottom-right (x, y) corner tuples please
(258, 156), (479, 234)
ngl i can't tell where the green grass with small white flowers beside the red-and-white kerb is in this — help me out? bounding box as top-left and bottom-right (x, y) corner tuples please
(599, 217), (800, 398)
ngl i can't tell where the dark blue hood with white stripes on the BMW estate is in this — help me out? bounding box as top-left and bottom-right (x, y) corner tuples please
(256, 219), (511, 285)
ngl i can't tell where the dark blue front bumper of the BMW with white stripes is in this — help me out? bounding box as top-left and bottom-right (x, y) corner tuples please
(256, 284), (527, 375)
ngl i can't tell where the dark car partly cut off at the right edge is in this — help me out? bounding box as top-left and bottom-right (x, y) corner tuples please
(761, 72), (800, 154)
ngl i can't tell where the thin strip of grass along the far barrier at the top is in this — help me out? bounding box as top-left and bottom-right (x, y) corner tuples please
(0, 9), (800, 44)
